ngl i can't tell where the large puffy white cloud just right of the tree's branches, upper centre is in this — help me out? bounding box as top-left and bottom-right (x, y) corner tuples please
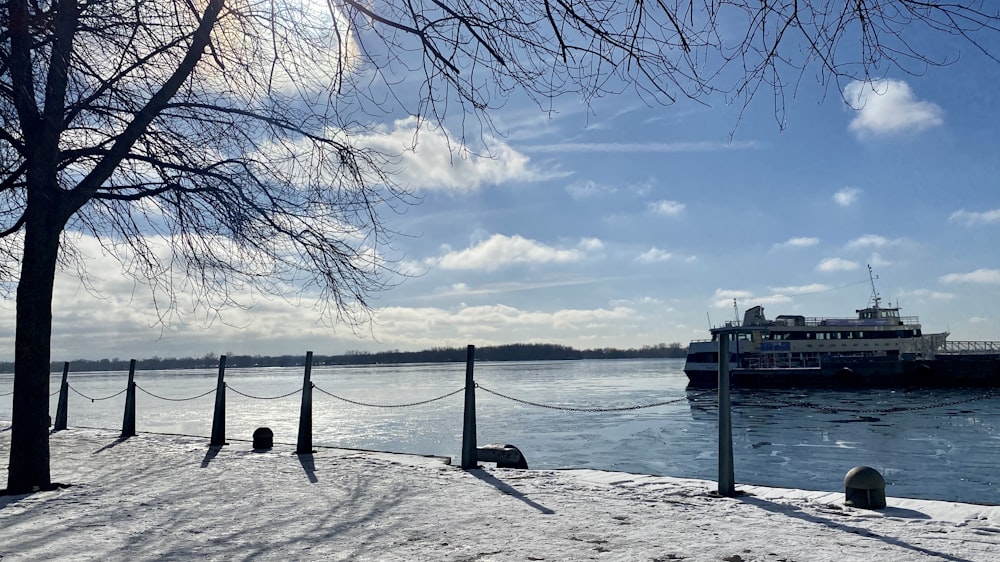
(360, 117), (565, 192)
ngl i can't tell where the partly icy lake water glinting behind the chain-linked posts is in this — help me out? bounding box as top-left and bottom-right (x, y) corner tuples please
(0, 360), (1000, 505)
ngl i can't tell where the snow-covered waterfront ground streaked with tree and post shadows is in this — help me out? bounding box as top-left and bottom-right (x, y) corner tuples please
(0, 428), (1000, 562)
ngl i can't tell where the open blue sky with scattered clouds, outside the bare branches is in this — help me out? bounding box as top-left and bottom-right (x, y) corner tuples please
(0, 8), (1000, 361)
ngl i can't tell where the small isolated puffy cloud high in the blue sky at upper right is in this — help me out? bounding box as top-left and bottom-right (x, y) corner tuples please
(844, 80), (944, 137)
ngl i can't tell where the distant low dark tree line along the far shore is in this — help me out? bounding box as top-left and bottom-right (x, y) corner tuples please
(0, 343), (687, 373)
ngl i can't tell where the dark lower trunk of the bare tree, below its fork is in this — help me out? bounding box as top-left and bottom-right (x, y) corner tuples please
(7, 205), (65, 494)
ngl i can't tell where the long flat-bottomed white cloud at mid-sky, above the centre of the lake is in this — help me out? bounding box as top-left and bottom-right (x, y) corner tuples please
(430, 234), (603, 271)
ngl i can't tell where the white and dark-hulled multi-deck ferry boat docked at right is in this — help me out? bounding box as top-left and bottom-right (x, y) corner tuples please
(684, 267), (1000, 388)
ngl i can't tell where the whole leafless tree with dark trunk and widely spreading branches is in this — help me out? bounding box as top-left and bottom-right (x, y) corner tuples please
(0, 0), (998, 493)
